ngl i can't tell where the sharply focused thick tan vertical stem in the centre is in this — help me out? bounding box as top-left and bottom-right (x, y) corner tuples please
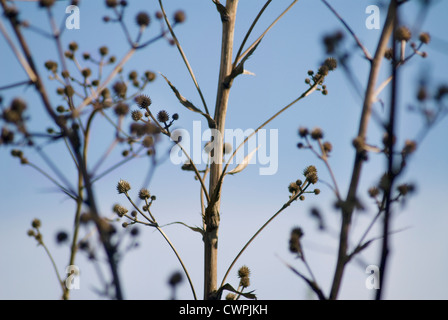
(204, 0), (238, 299)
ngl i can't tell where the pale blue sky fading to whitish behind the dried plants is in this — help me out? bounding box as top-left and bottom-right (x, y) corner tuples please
(0, 0), (448, 299)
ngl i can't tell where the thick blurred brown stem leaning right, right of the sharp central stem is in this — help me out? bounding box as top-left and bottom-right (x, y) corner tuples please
(330, 1), (396, 299)
